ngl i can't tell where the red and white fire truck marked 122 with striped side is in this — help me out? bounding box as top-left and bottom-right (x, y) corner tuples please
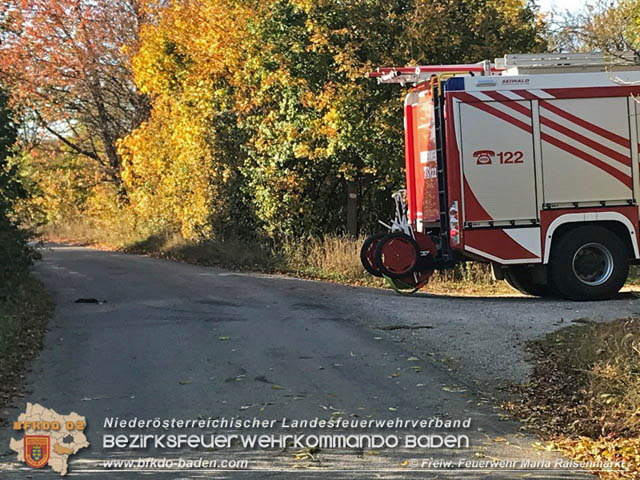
(361, 54), (640, 300)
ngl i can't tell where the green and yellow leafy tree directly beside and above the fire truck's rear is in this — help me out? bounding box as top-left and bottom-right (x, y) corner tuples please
(232, 0), (543, 236)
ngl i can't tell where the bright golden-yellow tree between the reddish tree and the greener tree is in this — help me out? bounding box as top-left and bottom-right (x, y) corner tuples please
(120, 0), (252, 238)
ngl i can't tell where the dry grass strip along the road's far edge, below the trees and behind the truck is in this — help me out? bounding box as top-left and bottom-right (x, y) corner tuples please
(43, 223), (516, 295)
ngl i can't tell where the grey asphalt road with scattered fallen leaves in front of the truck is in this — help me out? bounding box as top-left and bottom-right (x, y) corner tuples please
(5, 246), (640, 479)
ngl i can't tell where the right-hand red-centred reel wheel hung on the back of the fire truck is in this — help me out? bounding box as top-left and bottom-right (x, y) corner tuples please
(374, 232), (420, 279)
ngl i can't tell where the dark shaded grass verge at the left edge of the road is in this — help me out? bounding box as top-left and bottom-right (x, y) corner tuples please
(0, 277), (53, 420)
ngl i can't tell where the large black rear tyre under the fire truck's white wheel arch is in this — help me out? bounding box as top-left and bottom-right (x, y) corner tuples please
(550, 226), (629, 300)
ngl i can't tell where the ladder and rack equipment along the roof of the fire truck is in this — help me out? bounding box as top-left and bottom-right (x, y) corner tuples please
(368, 52), (640, 85)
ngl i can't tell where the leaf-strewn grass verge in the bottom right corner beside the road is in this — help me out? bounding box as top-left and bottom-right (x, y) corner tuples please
(505, 318), (640, 479)
